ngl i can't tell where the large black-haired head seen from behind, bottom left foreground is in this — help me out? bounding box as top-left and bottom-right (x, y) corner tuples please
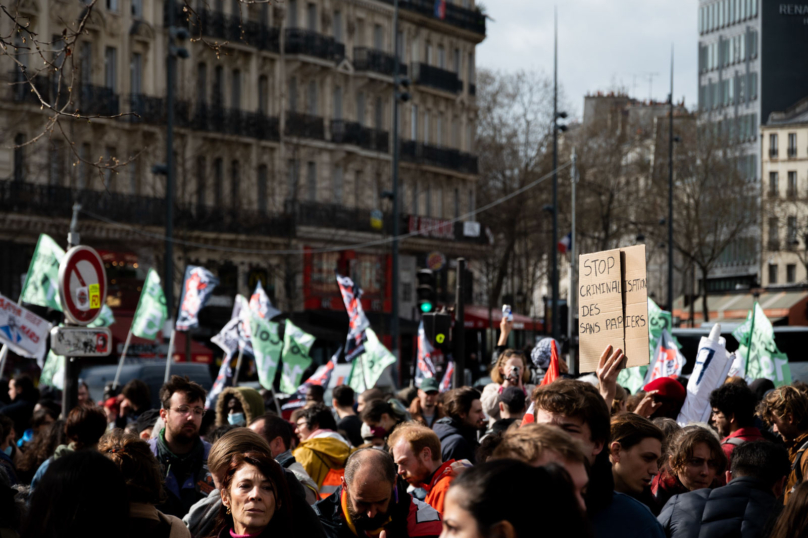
(20, 450), (129, 538)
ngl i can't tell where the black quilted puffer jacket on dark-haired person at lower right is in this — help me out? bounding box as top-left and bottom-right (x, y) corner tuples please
(658, 476), (782, 538)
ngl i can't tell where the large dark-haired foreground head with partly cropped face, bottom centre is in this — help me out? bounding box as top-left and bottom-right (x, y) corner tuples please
(441, 459), (592, 538)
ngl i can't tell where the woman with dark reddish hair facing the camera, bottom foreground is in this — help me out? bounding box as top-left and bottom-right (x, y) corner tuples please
(214, 452), (293, 538)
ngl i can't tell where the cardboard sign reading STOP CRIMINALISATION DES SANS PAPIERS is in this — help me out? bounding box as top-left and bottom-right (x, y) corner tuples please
(578, 245), (649, 372)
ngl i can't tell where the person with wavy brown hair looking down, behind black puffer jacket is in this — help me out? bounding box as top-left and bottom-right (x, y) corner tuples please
(651, 425), (727, 507)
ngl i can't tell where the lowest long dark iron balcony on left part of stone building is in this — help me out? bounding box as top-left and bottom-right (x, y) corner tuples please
(0, 181), (295, 237)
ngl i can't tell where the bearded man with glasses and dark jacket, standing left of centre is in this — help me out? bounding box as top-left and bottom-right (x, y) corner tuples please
(149, 375), (215, 518)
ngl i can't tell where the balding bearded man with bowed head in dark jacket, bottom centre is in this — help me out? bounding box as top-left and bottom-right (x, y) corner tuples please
(314, 448), (442, 538)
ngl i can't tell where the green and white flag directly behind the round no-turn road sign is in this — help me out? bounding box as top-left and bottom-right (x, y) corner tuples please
(20, 234), (65, 312)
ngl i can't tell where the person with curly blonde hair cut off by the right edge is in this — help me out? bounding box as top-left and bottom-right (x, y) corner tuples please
(757, 385), (808, 504)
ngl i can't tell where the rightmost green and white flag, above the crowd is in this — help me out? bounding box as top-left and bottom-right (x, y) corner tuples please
(732, 302), (791, 387)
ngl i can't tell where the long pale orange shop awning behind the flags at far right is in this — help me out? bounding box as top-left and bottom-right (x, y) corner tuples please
(673, 289), (808, 325)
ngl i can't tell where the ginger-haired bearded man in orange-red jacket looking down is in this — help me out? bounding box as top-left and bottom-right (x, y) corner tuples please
(387, 423), (455, 515)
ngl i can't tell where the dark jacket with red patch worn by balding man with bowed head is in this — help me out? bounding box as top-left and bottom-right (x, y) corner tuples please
(316, 483), (441, 538)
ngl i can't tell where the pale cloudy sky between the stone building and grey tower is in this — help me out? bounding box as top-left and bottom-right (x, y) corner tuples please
(477, 0), (698, 117)
